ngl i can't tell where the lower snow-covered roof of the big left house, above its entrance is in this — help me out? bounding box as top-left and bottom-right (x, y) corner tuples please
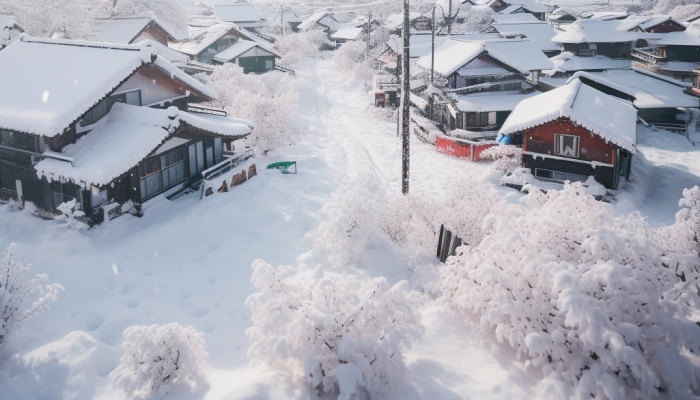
(34, 103), (251, 187)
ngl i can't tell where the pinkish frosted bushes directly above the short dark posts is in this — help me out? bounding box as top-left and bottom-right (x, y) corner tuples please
(379, 180), (501, 253)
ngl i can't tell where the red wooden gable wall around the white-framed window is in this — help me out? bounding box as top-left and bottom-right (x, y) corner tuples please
(523, 118), (617, 165)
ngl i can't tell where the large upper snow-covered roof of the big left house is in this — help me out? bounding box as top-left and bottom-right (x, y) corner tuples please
(0, 35), (216, 137)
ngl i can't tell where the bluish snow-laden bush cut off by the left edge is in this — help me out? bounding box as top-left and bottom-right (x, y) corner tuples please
(0, 243), (63, 343)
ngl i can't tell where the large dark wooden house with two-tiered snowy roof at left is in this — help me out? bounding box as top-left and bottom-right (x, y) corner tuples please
(0, 36), (252, 221)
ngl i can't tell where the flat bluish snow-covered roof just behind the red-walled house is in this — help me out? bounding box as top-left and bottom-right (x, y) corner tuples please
(569, 70), (698, 109)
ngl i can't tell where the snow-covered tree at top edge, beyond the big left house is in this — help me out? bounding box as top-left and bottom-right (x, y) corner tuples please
(100, 0), (187, 34)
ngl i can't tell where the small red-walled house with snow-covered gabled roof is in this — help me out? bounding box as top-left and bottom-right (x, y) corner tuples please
(500, 79), (637, 190)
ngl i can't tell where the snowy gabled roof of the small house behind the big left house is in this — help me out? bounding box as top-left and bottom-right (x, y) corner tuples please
(168, 22), (279, 56)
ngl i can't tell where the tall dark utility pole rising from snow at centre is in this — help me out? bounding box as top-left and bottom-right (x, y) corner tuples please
(401, 0), (411, 195)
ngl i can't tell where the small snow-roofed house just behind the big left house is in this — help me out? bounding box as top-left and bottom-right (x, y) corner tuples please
(169, 23), (280, 72)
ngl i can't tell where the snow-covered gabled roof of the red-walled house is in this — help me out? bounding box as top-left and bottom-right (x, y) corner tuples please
(500, 79), (637, 152)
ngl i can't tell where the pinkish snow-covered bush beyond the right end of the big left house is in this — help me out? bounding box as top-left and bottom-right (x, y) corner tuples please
(201, 63), (305, 155)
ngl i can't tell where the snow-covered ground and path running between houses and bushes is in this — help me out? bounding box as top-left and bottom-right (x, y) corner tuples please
(0, 54), (700, 399)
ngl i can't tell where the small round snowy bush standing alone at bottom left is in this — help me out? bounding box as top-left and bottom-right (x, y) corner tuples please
(109, 323), (207, 397)
